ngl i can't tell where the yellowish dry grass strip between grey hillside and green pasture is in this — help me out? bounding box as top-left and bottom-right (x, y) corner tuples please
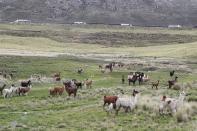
(0, 24), (197, 58)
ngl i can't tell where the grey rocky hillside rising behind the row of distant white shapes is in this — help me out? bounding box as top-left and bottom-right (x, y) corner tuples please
(0, 0), (197, 26)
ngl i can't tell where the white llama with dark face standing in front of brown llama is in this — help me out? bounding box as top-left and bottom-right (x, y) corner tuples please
(116, 89), (139, 115)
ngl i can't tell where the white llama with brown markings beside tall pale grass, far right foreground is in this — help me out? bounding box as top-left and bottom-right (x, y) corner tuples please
(159, 91), (186, 114)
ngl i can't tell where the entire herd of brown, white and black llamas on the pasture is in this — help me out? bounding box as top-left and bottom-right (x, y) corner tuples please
(0, 63), (194, 118)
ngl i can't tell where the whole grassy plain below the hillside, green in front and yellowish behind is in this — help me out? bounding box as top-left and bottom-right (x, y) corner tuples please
(0, 24), (197, 131)
